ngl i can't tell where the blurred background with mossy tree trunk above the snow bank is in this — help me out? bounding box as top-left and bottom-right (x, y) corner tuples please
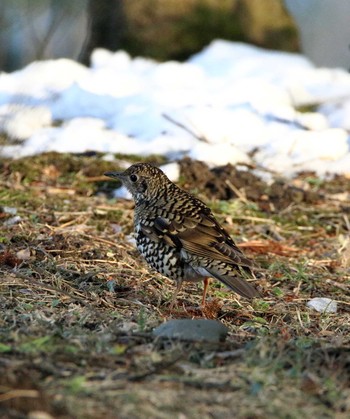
(0, 0), (350, 72)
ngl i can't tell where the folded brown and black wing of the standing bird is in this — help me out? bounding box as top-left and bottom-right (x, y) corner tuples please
(141, 208), (253, 267)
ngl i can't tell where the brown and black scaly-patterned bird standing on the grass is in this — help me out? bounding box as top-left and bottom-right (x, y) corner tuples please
(104, 163), (260, 308)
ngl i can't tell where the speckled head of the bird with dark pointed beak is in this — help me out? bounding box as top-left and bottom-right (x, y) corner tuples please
(104, 163), (170, 202)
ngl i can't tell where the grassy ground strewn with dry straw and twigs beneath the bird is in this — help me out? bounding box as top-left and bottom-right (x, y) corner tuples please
(0, 153), (350, 419)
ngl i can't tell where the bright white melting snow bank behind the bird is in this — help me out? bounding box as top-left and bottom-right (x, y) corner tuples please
(0, 40), (350, 179)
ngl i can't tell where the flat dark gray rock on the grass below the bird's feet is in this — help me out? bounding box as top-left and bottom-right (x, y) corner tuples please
(153, 319), (228, 343)
